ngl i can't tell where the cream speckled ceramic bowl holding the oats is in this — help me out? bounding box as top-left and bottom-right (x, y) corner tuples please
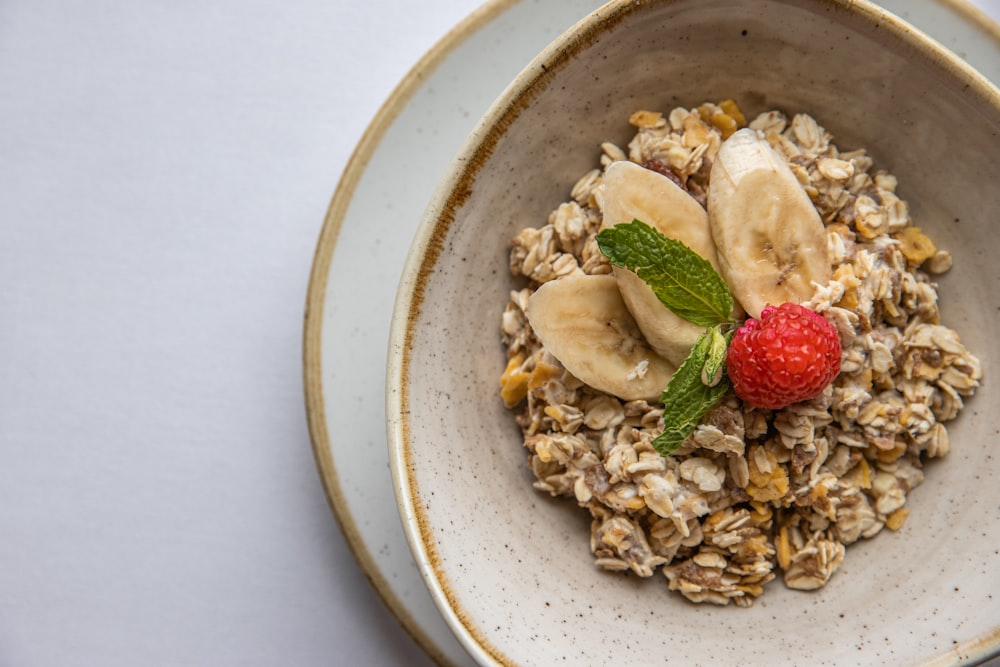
(387, 0), (1000, 666)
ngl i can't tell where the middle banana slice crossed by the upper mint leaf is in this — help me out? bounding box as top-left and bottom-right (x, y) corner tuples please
(603, 161), (719, 366)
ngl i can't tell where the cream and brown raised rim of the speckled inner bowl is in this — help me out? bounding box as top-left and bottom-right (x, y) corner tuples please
(385, 0), (1000, 667)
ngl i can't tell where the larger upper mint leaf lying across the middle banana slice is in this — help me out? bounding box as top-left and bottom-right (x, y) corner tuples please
(597, 220), (733, 327)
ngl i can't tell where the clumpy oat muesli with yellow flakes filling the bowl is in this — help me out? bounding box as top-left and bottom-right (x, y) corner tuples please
(501, 101), (982, 606)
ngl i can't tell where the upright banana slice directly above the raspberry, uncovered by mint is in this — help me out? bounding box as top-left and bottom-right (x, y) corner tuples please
(708, 128), (832, 317)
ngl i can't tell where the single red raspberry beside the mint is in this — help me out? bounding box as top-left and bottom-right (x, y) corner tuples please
(726, 303), (840, 410)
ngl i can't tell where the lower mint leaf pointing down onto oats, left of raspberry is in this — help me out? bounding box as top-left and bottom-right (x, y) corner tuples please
(653, 325), (733, 456)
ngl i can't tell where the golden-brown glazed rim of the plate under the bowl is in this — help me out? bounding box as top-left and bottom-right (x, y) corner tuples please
(303, 0), (1000, 667)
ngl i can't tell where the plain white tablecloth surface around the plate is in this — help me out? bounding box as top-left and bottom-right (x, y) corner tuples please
(0, 0), (1000, 667)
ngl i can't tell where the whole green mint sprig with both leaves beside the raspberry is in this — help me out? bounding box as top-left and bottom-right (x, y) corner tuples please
(597, 220), (735, 456)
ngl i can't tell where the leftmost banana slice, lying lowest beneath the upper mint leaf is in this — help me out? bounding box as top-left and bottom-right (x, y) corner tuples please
(526, 275), (675, 401)
